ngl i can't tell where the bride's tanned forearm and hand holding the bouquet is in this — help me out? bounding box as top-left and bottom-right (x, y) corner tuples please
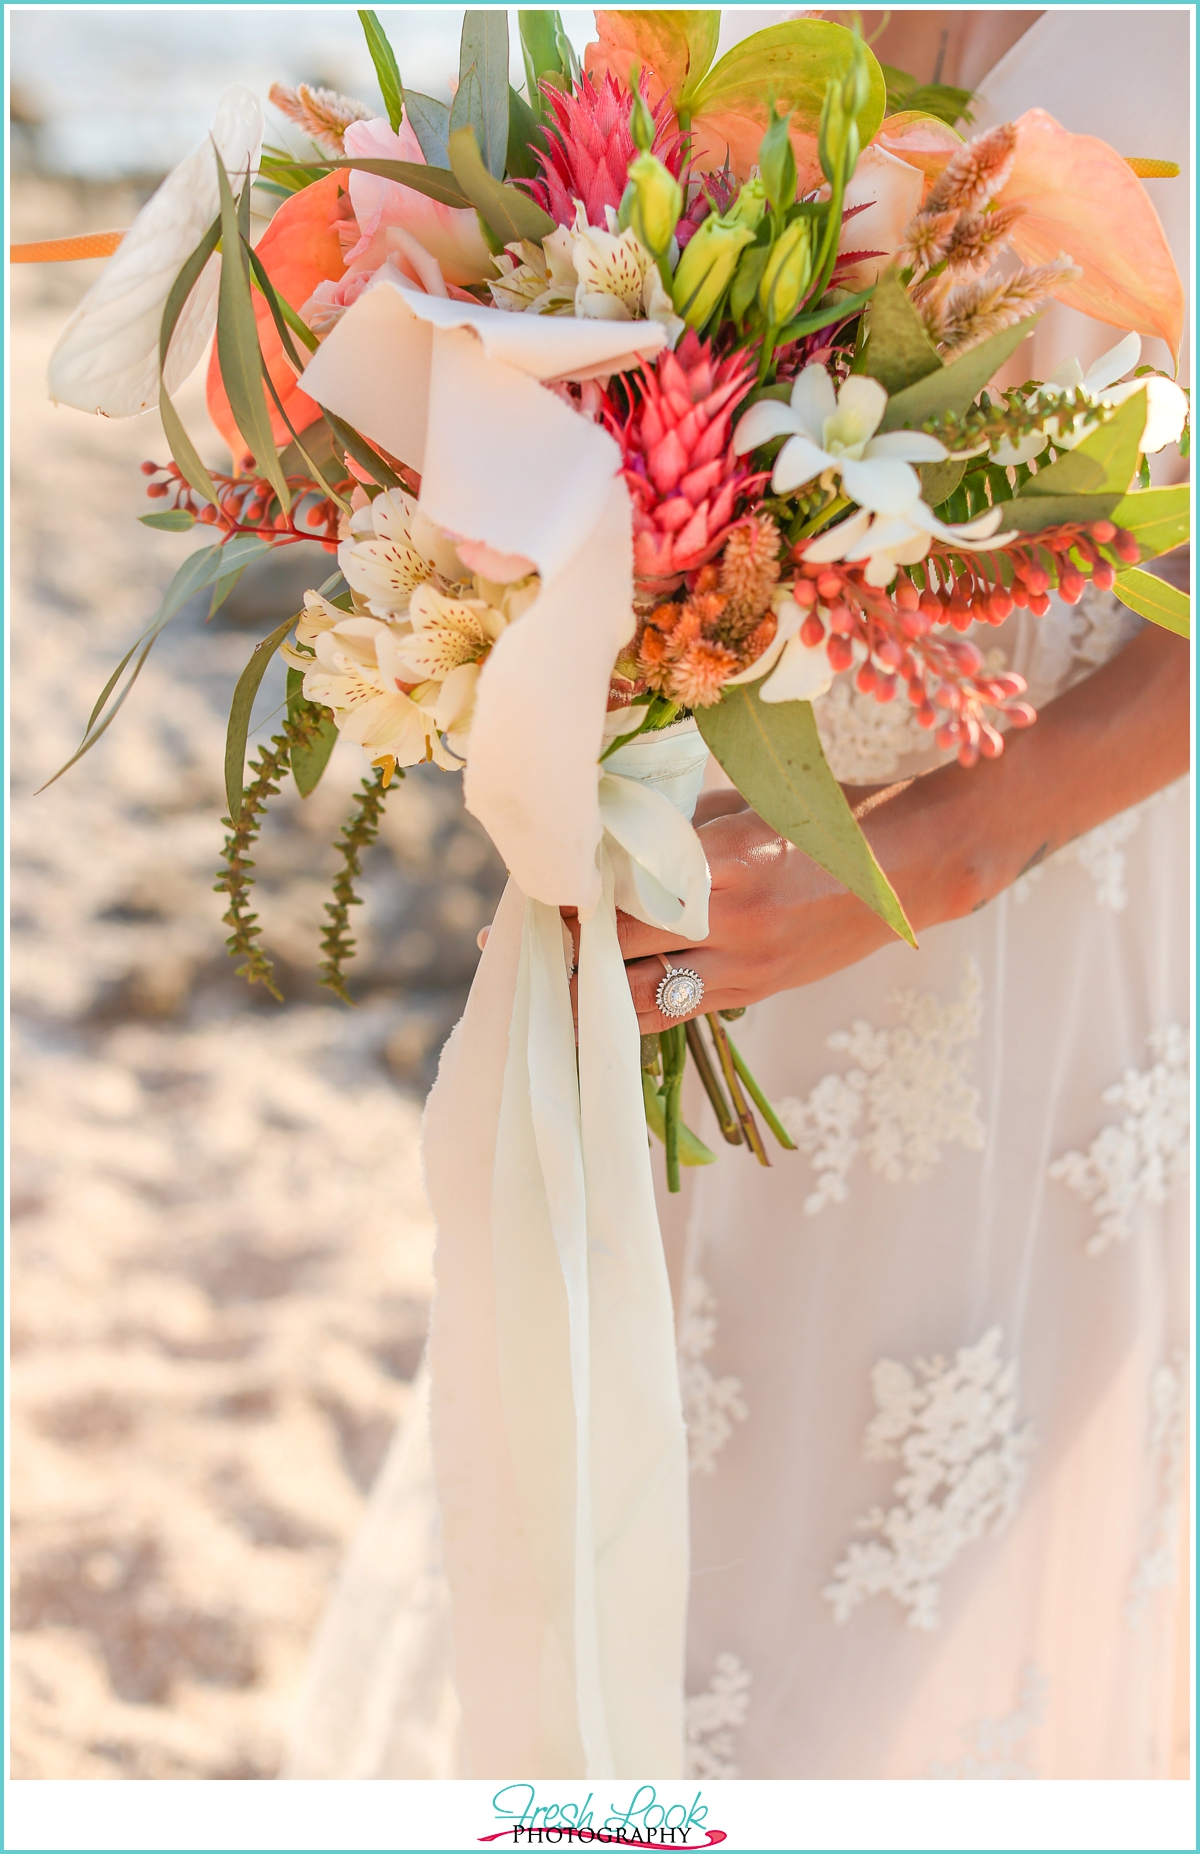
(619, 625), (1189, 1031)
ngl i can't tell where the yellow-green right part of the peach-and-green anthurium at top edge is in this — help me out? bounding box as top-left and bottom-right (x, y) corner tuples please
(689, 13), (887, 146)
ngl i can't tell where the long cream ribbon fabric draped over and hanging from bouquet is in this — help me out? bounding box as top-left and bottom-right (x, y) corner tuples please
(304, 286), (709, 1778)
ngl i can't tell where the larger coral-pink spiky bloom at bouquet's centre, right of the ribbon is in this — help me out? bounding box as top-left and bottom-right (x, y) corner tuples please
(610, 328), (766, 590)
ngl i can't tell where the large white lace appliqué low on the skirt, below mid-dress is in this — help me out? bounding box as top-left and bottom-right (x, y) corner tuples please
(822, 1326), (1033, 1630)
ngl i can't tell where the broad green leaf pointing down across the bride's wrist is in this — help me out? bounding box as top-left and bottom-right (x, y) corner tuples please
(696, 682), (916, 946)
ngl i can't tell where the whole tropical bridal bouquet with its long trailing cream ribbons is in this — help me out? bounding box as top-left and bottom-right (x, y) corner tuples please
(35, 9), (1187, 1774)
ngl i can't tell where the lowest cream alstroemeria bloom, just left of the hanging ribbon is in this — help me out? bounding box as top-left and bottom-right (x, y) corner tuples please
(289, 614), (456, 768)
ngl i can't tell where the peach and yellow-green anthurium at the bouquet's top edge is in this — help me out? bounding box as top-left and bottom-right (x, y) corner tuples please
(584, 9), (885, 193)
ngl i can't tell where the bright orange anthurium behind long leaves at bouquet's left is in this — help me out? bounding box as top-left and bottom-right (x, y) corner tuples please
(208, 174), (345, 460)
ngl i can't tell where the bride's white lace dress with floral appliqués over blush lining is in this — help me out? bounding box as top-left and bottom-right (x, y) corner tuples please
(287, 9), (1191, 1778)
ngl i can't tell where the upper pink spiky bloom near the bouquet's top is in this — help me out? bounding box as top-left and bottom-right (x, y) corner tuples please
(523, 74), (688, 230)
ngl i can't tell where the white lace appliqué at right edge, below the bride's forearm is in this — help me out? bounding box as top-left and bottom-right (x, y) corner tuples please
(1050, 1023), (1191, 1255)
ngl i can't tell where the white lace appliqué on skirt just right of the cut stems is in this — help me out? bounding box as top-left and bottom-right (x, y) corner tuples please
(779, 959), (985, 1216)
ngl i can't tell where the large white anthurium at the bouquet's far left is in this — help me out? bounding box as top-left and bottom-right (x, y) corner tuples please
(48, 83), (263, 419)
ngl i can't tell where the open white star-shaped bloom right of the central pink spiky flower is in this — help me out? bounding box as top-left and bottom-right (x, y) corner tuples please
(733, 362), (946, 515)
